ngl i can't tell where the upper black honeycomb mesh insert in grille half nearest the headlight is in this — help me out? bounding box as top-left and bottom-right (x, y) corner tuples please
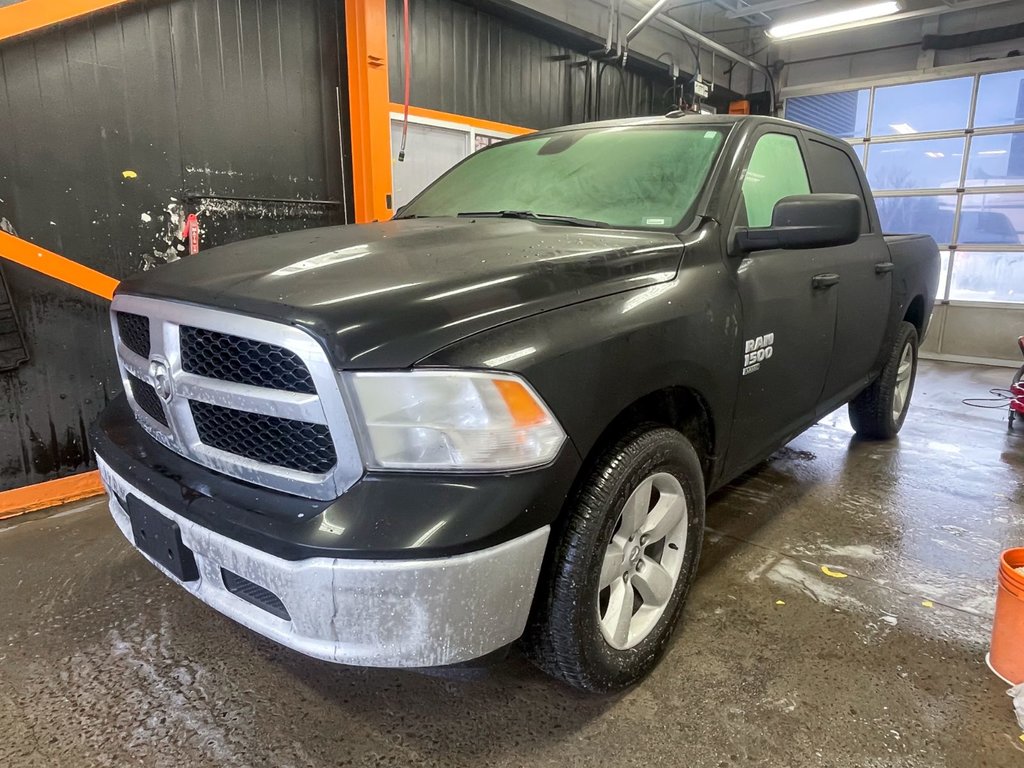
(181, 326), (316, 394)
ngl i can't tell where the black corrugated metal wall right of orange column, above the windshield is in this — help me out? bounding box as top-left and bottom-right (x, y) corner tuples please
(388, 0), (672, 128)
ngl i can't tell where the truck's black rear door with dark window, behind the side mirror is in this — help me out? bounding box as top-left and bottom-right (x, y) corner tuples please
(805, 134), (893, 415)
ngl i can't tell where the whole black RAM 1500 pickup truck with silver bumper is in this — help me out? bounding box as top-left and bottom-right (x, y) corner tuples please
(93, 116), (939, 691)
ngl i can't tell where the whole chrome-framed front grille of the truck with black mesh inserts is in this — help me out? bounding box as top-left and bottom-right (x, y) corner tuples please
(112, 294), (362, 500)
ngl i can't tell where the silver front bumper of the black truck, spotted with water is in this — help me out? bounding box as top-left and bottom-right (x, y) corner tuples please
(96, 456), (550, 667)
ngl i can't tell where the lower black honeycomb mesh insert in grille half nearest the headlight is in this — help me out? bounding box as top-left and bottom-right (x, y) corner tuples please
(189, 400), (338, 473)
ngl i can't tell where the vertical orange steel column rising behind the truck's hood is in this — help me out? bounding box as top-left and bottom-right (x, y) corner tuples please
(345, 0), (391, 222)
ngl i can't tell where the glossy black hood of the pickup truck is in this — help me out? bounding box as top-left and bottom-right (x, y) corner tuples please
(118, 218), (683, 368)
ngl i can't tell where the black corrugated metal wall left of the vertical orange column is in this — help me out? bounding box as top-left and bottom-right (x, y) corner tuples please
(0, 0), (350, 490)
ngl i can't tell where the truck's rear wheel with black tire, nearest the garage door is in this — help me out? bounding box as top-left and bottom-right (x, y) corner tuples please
(850, 322), (918, 440)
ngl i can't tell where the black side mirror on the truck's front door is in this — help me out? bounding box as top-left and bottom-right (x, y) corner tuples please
(729, 193), (861, 255)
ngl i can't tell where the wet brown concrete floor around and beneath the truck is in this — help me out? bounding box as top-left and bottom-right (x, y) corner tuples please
(0, 362), (1024, 768)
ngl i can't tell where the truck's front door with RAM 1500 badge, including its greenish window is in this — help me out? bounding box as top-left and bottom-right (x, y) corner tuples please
(726, 126), (837, 470)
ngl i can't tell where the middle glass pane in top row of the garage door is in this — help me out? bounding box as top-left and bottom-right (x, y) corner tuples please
(871, 77), (974, 136)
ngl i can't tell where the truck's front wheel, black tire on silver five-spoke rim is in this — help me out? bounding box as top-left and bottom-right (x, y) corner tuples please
(528, 425), (705, 693)
